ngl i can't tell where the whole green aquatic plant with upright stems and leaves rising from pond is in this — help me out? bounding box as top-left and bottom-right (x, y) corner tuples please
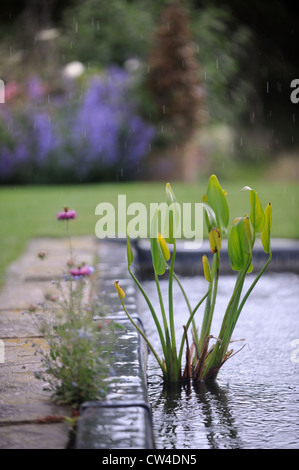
(115, 175), (272, 383)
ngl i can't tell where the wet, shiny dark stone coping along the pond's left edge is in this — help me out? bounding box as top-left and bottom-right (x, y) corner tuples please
(76, 242), (154, 449)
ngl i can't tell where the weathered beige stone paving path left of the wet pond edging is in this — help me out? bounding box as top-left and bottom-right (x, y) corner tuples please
(0, 237), (98, 449)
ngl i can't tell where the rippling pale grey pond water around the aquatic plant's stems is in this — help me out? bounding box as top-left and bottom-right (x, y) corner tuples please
(140, 273), (299, 449)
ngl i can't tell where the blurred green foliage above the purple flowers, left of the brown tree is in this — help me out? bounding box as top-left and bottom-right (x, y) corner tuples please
(59, 0), (154, 67)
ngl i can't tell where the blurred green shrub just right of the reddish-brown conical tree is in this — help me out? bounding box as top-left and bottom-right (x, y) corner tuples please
(191, 5), (252, 125)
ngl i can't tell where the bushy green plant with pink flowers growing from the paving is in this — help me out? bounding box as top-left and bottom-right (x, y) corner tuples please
(27, 208), (112, 410)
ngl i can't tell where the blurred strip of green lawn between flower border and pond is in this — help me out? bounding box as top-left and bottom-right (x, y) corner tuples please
(0, 175), (299, 285)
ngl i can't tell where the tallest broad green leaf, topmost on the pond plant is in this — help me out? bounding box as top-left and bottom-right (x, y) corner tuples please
(207, 175), (229, 233)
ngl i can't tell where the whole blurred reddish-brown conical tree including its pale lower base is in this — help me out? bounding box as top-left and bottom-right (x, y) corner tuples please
(144, 0), (204, 180)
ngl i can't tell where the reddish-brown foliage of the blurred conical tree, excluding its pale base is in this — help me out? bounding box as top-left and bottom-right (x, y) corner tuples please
(146, 1), (203, 142)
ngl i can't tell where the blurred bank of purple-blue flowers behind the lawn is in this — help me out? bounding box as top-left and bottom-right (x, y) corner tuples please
(0, 67), (154, 183)
